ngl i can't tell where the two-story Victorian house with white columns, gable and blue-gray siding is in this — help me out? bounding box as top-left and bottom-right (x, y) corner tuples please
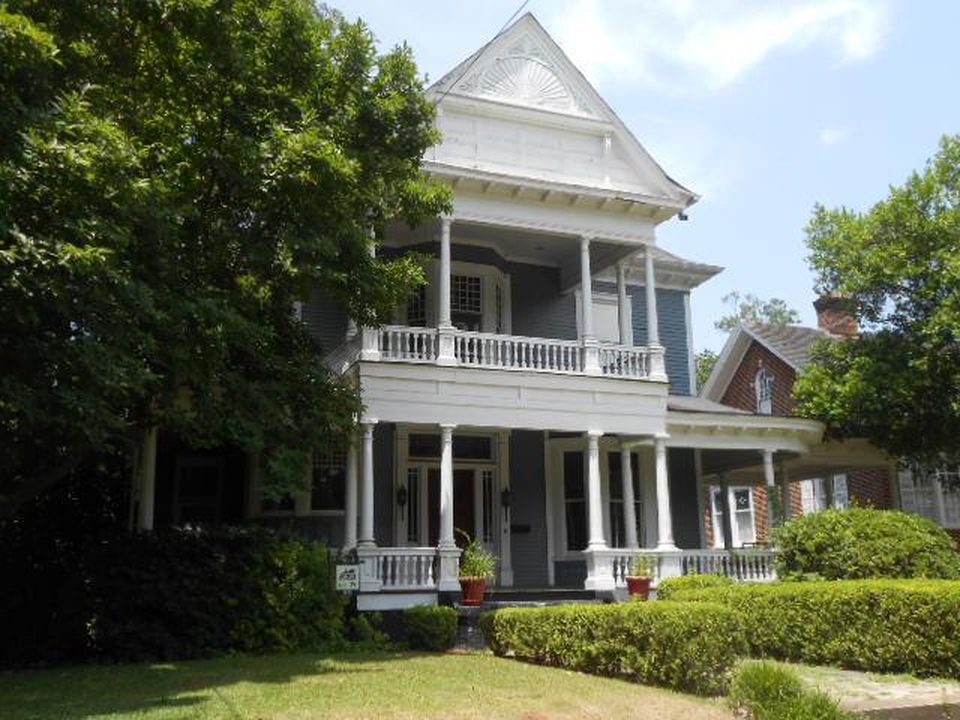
(129, 14), (864, 609)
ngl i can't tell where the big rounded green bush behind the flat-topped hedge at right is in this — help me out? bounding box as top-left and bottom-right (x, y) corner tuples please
(775, 508), (960, 580)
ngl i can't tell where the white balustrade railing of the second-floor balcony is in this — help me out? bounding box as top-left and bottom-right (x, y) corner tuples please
(326, 325), (665, 380)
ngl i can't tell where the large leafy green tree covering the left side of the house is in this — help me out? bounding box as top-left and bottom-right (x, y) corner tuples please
(0, 0), (449, 515)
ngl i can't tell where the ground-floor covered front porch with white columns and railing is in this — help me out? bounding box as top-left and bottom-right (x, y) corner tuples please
(343, 408), (818, 610)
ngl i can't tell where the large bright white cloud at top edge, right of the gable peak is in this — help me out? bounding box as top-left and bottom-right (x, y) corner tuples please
(548, 0), (891, 93)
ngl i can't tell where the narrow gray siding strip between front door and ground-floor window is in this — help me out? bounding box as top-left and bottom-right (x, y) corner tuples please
(510, 430), (548, 587)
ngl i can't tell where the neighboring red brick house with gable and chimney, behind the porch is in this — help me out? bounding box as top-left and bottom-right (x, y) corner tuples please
(700, 298), (894, 547)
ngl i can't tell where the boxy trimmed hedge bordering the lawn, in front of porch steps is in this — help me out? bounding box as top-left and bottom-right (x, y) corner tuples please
(481, 602), (744, 695)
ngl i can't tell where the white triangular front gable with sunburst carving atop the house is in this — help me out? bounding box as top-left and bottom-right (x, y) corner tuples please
(426, 14), (696, 212)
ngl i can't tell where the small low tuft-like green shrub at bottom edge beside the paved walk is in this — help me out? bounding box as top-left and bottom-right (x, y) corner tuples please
(730, 662), (856, 720)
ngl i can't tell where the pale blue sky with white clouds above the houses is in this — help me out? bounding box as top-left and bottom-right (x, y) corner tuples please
(331, 0), (960, 350)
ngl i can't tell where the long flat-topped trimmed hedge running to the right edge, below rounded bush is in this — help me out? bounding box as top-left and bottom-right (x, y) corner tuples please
(674, 580), (960, 678)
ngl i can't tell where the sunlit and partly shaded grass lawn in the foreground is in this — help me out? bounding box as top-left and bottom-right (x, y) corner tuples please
(0, 652), (731, 720)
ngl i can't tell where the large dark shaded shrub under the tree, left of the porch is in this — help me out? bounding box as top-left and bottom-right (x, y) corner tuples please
(88, 528), (345, 660)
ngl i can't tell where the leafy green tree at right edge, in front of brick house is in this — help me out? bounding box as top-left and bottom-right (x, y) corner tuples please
(794, 136), (960, 463)
